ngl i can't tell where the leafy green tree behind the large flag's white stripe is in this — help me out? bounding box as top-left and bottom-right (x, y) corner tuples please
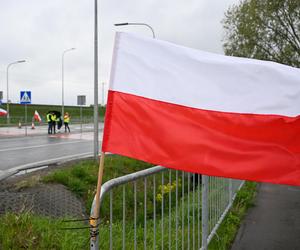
(223, 0), (300, 68)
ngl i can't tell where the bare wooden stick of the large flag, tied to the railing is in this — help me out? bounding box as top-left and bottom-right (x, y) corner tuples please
(90, 152), (105, 237)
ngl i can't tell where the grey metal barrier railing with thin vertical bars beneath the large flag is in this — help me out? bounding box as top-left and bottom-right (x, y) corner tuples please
(90, 166), (244, 250)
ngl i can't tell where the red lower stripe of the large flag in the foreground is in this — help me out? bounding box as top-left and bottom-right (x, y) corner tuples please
(102, 91), (300, 185)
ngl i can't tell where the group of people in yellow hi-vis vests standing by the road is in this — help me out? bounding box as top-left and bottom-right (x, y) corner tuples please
(46, 112), (71, 135)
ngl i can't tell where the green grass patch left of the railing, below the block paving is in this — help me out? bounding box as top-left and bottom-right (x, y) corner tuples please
(0, 213), (89, 250)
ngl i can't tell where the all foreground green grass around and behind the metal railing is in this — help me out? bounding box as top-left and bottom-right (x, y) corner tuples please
(0, 155), (256, 250)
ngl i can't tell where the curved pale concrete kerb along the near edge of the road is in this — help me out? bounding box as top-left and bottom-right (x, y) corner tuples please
(0, 153), (93, 181)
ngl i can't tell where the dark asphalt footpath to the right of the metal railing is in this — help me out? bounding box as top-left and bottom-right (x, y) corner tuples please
(231, 184), (300, 250)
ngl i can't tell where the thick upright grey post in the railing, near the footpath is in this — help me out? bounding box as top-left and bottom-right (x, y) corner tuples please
(201, 175), (209, 250)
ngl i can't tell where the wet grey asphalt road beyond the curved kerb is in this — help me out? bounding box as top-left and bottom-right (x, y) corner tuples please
(0, 132), (102, 172)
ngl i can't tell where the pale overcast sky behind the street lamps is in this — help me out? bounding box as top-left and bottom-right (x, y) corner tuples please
(0, 0), (238, 105)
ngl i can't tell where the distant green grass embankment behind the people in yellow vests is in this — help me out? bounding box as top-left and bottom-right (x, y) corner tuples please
(0, 103), (105, 125)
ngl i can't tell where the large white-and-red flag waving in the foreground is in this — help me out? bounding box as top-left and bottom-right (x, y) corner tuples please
(102, 33), (300, 185)
